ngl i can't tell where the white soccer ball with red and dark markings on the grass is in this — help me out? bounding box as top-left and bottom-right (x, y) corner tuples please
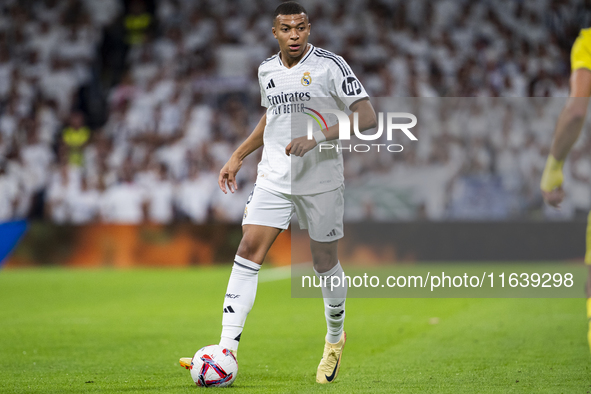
(191, 345), (238, 387)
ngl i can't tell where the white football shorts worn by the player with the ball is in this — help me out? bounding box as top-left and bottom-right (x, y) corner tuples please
(242, 184), (345, 242)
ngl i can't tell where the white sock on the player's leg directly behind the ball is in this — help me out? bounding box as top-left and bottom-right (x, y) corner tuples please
(220, 255), (261, 350)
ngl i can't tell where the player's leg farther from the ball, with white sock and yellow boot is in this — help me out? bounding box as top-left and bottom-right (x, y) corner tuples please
(310, 240), (347, 383)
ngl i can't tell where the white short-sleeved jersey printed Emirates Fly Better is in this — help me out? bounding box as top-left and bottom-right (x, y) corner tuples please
(256, 44), (368, 195)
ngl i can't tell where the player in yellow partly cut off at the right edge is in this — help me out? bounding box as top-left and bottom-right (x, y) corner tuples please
(540, 28), (591, 347)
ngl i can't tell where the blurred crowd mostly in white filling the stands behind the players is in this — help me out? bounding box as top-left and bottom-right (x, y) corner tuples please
(0, 0), (591, 224)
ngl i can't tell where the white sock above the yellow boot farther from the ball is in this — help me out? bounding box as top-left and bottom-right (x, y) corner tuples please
(314, 262), (348, 343)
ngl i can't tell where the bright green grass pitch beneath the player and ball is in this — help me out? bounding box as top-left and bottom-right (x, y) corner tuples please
(0, 266), (591, 393)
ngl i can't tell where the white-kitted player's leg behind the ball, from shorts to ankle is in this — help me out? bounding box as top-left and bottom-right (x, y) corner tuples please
(220, 224), (281, 353)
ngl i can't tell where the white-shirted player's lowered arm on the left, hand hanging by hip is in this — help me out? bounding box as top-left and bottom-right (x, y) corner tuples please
(218, 112), (267, 194)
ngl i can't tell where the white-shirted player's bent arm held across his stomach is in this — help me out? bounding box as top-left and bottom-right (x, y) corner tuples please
(285, 97), (378, 157)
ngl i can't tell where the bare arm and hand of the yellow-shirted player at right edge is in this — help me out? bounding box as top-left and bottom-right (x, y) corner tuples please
(540, 68), (591, 207)
